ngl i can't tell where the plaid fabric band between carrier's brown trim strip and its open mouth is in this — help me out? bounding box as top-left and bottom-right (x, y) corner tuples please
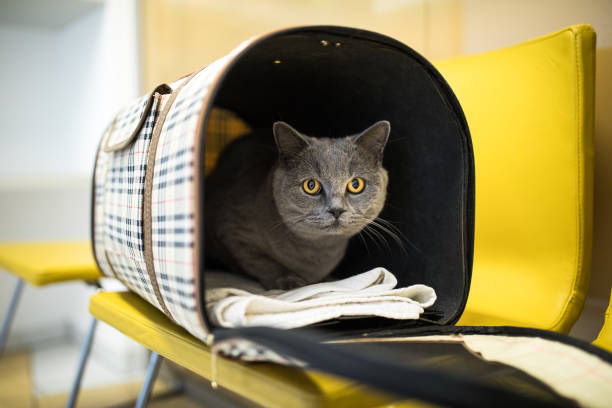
(151, 61), (232, 340)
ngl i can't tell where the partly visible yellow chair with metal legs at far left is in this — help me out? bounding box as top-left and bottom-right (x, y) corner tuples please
(0, 241), (102, 407)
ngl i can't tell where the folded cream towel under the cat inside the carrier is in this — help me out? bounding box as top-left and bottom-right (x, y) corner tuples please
(205, 268), (436, 329)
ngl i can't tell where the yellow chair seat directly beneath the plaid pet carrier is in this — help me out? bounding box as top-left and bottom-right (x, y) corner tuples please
(89, 292), (425, 407)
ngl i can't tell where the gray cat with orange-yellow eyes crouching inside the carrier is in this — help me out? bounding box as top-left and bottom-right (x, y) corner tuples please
(204, 121), (390, 289)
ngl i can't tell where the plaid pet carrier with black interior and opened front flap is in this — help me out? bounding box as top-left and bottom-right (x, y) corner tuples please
(92, 27), (611, 406)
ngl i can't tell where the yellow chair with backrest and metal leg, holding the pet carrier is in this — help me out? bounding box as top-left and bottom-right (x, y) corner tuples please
(85, 25), (595, 406)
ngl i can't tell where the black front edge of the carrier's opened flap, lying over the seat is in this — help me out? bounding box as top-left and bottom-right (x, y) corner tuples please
(214, 327), (576, 408)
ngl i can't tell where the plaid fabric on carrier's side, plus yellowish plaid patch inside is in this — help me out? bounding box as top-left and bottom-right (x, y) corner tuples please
(93, 37), (256, 341)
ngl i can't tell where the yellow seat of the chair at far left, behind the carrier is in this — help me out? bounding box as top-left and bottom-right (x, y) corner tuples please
(0, 241), (102, 286)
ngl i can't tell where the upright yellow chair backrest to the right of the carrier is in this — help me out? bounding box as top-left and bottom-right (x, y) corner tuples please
(436, 25), (595, 332)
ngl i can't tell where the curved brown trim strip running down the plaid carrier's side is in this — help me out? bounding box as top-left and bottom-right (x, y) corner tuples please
(142, 74), (194, 321)
